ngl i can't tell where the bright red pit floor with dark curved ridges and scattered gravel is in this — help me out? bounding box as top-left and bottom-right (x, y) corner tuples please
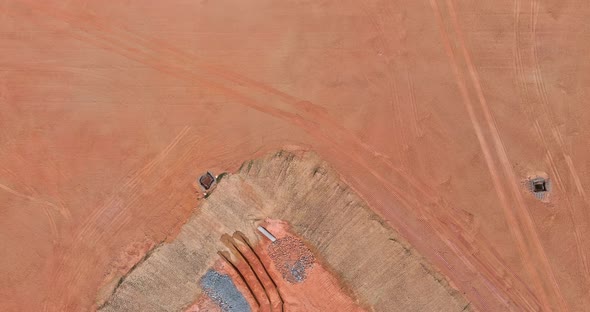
(185, 220), (364, 312)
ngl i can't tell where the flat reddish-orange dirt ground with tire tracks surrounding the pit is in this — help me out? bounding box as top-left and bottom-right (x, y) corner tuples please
(0, 0), (590, 311)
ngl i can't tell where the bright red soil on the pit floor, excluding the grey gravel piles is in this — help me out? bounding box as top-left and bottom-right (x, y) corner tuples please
(185, 219), (364, 312)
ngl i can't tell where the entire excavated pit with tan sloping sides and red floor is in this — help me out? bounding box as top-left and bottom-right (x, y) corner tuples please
(97, 151), (473, 312)
